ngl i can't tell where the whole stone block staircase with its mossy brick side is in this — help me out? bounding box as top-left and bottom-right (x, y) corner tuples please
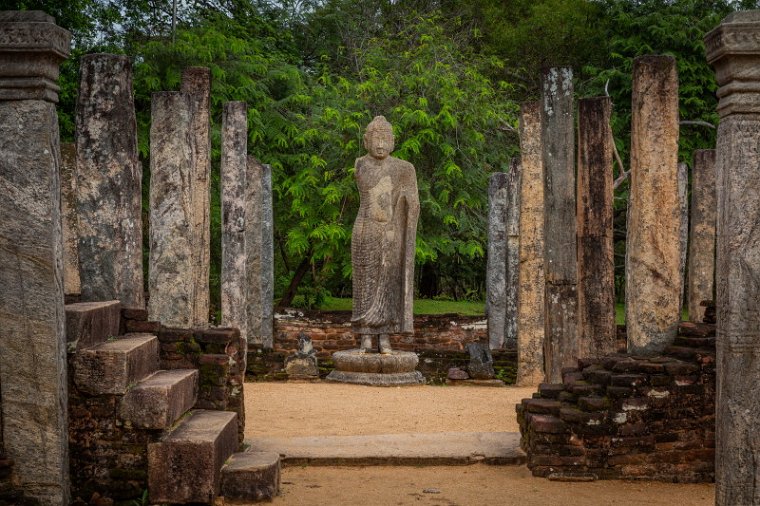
(66, 301), (279, 504)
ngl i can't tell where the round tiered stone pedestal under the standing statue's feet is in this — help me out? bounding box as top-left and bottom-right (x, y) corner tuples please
(327, 350), (425, 386)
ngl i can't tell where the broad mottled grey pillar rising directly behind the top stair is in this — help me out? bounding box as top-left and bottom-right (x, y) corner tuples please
(76, 54), (145, 308)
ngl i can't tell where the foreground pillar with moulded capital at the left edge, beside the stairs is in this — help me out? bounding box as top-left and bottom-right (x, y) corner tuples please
(0, 11), (71, 505)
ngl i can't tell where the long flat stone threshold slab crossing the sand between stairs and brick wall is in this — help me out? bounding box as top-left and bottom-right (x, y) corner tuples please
(246, 432), (526, 466)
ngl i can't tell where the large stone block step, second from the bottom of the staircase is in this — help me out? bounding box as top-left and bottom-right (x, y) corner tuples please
(148, 410), (238, 504)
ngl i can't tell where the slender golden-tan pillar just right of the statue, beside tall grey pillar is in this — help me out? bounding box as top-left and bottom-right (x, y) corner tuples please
(517, 102), (545, 386)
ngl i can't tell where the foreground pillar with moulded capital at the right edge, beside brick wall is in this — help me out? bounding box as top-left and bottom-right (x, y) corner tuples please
(705, 10), (760, 506)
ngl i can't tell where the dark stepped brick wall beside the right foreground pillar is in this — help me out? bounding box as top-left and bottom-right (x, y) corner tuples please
(517, 323), (715, 482)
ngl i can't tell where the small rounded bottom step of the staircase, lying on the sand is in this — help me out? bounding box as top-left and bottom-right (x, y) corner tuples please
(221, 452), (280, 504)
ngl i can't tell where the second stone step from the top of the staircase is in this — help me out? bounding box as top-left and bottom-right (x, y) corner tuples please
(74, 334), (158, 395)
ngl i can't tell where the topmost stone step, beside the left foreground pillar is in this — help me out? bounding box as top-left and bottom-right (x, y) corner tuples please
(64, 300), (121, 353)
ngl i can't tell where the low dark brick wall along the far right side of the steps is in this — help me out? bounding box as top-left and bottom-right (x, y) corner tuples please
(122, 309), (245, 441)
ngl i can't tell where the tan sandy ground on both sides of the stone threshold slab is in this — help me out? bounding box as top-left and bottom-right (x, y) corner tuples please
(245, 383), (714, 506)
